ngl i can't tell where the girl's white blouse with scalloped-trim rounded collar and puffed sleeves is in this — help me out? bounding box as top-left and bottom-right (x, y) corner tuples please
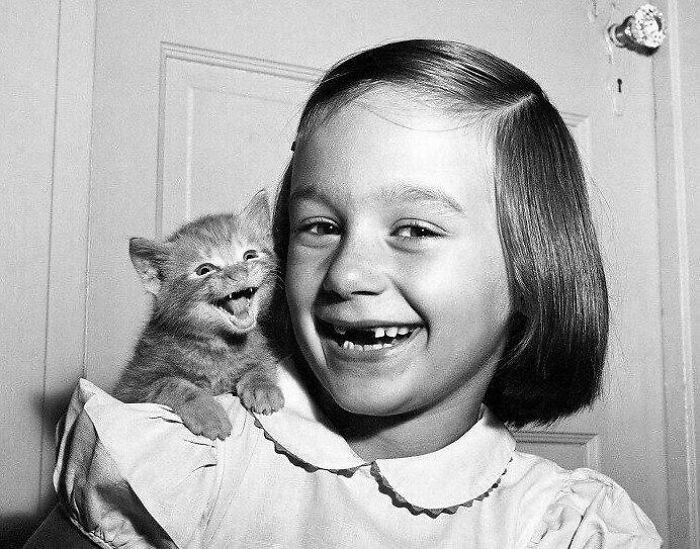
(54, 362), (661, 549)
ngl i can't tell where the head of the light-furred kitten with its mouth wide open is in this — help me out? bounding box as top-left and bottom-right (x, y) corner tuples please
(132, 195), (276, 336)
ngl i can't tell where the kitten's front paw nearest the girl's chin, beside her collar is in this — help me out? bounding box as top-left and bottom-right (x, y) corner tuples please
(236, 359), (284, 415)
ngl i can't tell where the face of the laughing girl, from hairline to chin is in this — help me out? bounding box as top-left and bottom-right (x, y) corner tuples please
(286, 95), (510, 416)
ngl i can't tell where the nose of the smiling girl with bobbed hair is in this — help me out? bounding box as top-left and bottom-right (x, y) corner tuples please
(323, 231), (387, 299)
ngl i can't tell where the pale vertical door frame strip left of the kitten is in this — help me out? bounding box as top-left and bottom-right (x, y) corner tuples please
(37, 0), (97, 516)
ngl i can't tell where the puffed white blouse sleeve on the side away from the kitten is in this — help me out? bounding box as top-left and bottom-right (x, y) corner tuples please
(528, 469), (661, 549)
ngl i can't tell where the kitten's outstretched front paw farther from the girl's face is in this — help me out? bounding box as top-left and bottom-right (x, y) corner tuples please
(147, 377), (231, 440)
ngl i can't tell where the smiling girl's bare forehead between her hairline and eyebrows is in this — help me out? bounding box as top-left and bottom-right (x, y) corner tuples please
(292, 96), (493, 211)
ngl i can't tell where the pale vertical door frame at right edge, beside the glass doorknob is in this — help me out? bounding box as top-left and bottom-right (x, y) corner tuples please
(653, 0), (700, 549)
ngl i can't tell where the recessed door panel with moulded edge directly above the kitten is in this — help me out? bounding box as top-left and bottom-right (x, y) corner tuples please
(156, 44), (320, 234)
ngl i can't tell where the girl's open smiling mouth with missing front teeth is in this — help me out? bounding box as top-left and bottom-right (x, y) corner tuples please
(316, 319), (420, 352)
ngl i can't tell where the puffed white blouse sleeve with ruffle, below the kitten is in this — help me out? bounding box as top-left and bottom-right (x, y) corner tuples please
(54, 380), (260, 548)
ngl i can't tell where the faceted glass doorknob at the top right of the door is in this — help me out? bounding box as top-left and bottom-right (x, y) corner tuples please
(608, 4), (666, 55)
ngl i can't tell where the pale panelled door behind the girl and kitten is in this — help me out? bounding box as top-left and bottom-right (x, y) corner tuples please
(80, 0), (668, 537)
